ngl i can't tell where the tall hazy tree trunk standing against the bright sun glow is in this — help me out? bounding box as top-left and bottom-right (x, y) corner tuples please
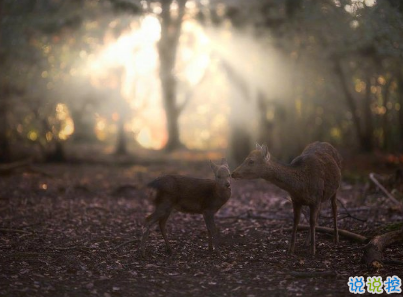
(158, 0), (186, 151)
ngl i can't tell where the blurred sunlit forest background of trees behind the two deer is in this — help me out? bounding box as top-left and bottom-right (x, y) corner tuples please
(0, 0), (403, 163)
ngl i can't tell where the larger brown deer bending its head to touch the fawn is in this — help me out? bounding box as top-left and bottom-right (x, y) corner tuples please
(231, 141), (341, 256)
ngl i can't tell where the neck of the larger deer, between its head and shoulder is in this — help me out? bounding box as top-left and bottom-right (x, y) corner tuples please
(262, 161), (300, 194)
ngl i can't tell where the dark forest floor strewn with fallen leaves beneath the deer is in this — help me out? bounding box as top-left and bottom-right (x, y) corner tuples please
(0, 156), (403, 297)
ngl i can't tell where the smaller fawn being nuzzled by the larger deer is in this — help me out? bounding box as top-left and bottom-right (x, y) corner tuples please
(140, 159), (231, 256)
